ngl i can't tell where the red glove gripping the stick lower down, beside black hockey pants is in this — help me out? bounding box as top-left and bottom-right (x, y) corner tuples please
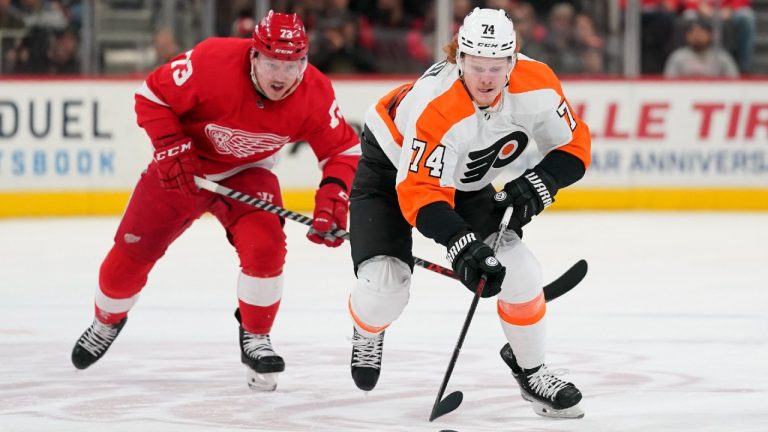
(307, 183), (349, 247)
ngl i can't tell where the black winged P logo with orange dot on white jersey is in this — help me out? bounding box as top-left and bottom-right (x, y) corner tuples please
(461, 131), (528, 183)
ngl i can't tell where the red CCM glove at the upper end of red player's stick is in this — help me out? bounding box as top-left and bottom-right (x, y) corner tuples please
(154, 137), (202, 196)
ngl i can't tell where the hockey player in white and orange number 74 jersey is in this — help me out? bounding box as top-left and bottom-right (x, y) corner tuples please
(348, 8), (591, 418)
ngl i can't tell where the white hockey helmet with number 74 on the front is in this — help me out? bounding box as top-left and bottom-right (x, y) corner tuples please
(457, 8), (517, 58)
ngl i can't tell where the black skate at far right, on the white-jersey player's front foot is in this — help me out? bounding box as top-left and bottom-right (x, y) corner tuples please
(500, 344), (584, 418)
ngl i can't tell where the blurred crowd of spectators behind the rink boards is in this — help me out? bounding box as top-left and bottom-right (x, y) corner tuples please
(0, 0), (756, 77)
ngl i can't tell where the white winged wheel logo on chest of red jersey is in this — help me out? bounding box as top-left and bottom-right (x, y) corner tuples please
(205, 124), (290, 158)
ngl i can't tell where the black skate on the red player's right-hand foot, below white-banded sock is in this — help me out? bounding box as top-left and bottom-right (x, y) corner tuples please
(235, 309), (285, 391)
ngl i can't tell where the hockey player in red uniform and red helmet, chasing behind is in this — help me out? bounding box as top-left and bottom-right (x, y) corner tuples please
(72, 11), (360, 390)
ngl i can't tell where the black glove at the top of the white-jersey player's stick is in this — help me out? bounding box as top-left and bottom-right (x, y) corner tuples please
(493, 168), (558, 231)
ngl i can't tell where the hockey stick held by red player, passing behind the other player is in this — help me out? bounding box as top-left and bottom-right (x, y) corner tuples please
(195, 176), (587, 301)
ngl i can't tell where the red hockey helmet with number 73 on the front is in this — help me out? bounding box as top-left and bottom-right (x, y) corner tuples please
(253, 10), (309, 61)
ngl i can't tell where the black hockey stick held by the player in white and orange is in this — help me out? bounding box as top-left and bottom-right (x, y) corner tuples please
(429, 207), (512, 421)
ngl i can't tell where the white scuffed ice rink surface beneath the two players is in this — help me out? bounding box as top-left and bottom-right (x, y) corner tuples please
(0, 212), (768, 432)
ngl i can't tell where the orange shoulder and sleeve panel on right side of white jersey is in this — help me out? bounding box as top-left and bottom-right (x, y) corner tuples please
(507, 60), (592, 168)
